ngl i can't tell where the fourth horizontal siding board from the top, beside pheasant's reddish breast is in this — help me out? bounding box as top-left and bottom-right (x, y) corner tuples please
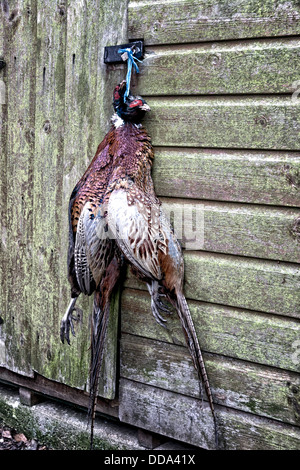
(152, 147), (300, 207)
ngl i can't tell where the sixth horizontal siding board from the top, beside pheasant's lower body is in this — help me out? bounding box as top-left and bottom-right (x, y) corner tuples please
(125, 251), (300, 319)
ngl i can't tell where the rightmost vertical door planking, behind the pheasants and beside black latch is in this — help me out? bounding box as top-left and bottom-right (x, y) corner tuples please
(59, 0), (127, 398)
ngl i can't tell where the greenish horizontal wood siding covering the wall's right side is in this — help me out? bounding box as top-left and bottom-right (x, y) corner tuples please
(120, 0), (300, 450)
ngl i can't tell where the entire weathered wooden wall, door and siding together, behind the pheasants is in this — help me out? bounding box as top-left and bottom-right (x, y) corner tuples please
(0, 0), (300, 449)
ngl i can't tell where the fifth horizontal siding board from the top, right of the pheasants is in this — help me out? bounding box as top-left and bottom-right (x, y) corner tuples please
(161, 198), (300, 263)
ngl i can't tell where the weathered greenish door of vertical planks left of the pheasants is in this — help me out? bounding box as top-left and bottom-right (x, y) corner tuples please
(0, 0), (127, 398)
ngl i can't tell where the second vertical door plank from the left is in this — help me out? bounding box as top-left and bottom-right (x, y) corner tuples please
(32, 0), (67, 379)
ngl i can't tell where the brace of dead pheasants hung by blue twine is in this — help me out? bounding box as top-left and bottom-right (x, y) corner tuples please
(61, 81), (216, 448)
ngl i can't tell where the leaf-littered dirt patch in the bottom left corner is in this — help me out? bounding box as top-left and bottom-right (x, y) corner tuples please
(0, 425), (49, 450)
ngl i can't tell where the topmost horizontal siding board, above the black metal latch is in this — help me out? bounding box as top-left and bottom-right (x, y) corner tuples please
(128, 0), (300, 44)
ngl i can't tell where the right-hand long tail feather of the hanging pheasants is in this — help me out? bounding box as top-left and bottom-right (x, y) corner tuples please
(177, 293), (218, 448)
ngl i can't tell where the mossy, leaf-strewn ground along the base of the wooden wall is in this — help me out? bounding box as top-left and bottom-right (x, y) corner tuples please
(0, 384), (197, 450)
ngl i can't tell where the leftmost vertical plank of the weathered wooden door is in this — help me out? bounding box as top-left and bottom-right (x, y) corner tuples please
(2, 0), (36, 375)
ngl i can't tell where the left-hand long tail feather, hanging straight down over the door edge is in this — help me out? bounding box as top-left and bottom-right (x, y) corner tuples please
(88, 293), (109, 449)
